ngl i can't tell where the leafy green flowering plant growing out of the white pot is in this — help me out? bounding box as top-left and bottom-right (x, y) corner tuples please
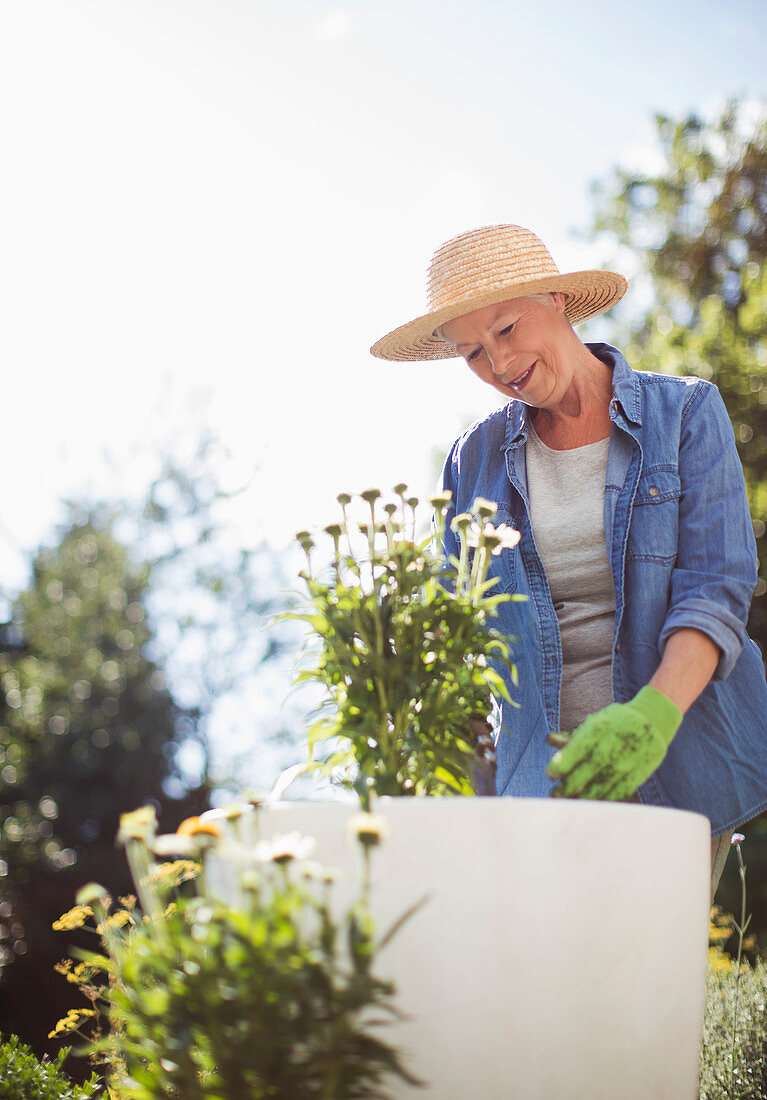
(288, 486), (517, 801)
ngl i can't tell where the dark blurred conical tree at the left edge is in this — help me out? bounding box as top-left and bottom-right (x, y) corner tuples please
(0, 517), (205, 1064)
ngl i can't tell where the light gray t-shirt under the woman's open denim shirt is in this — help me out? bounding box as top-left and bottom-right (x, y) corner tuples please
(526, 425), (615, 733)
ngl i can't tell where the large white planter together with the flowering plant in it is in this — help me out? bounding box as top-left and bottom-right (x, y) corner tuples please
(204, 485), (709, 1100)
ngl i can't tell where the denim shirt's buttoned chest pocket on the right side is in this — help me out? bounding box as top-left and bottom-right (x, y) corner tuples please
(626, 466), (681, 564)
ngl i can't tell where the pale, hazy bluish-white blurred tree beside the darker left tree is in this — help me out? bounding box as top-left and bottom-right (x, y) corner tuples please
(114, 429), (297, 789)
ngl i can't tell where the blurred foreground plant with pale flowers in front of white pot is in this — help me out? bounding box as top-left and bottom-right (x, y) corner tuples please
(67, 809), (418, 1100)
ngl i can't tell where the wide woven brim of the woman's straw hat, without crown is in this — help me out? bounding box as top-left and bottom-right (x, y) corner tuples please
(370, 271), (628, 363)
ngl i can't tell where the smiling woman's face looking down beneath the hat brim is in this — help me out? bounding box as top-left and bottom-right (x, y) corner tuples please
(440, 294), (573, 408)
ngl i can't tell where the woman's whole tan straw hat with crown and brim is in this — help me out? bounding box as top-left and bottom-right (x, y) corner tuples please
(370, 226), (628, 362)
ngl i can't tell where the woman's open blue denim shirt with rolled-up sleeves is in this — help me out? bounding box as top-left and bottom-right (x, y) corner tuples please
(442, 343), (767, 836)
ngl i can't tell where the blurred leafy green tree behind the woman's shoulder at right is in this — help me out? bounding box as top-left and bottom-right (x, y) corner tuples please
(593, 101), (767, 949)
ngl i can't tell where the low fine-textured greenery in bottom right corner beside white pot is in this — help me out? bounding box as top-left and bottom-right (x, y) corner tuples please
(700, 959), (767, 1100)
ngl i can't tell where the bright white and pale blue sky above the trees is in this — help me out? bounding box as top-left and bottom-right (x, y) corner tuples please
(0, 0), (767, 783)
